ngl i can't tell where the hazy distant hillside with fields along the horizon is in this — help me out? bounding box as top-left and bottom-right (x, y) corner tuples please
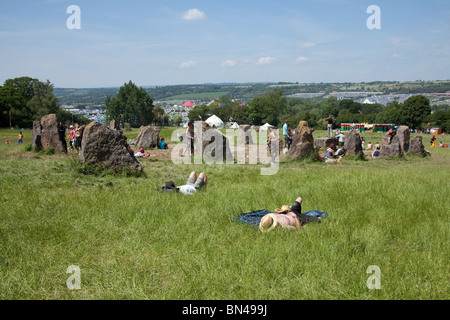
(54, 80), (450, 105)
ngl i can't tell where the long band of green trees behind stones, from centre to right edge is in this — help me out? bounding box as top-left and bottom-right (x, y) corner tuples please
(188, 90), (450, 132)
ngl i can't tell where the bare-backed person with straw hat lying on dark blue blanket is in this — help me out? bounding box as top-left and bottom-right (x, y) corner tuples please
(259, 197), (322, 232)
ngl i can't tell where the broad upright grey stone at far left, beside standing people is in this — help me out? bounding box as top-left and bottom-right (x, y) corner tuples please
(38, 114), (67, 153)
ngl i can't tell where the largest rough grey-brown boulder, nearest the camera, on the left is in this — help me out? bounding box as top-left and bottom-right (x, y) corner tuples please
(79, 122), (142, 172)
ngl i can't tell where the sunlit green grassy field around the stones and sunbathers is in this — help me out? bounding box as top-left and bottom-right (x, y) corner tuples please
(0, 128), (450, 300)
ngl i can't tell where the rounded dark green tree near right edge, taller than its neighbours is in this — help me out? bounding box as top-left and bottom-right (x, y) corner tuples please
(400, 95), (431, 129)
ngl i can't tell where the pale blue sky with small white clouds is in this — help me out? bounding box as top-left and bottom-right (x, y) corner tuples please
(0, 0), (450, 88)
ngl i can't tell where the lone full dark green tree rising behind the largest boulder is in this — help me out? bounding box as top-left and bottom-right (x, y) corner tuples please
(105, 81), (154, 127)
